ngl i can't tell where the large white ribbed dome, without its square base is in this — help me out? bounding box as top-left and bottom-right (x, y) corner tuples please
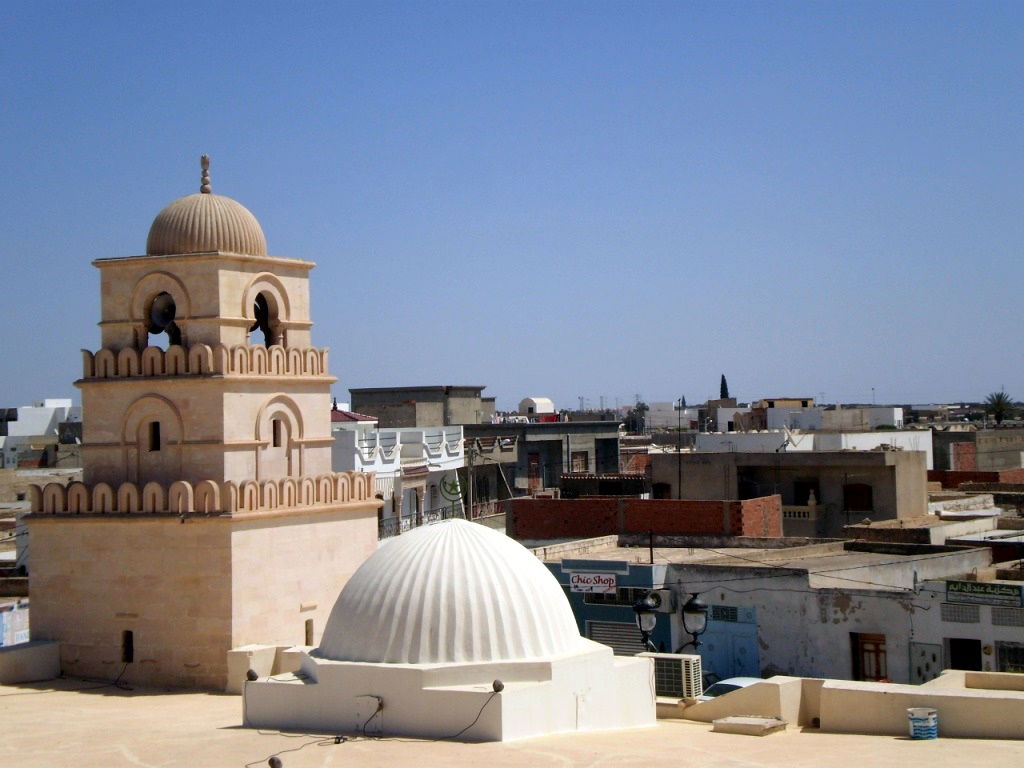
(317, 519), (584, 664)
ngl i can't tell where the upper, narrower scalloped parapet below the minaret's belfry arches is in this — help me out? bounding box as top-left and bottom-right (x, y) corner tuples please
(82, 344), (328, 380)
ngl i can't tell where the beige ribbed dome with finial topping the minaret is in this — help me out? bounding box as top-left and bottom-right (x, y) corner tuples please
(145, 155), (266, 256)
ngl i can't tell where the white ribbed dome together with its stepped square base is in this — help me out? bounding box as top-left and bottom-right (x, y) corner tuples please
(244, 520), (655, 741)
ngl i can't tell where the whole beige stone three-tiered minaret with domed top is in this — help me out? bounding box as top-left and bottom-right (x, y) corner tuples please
(27, 155), (379, 688)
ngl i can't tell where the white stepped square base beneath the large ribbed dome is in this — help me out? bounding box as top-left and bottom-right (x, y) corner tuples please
(243, 643), (655, 741)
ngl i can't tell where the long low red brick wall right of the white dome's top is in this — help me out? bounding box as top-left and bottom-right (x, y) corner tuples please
(506, 496), (782, 540)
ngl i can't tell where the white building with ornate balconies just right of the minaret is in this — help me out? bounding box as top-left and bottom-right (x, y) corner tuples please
(331, 411), (466, 539)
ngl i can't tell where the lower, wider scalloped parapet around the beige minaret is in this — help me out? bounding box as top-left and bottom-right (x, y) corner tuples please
(29, 472), (376, 515)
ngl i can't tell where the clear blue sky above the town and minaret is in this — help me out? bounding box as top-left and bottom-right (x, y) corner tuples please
(0, 0), (1024, 408)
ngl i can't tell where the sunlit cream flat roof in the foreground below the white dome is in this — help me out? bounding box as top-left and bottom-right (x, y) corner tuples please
(0, 680), (1024, 768)
